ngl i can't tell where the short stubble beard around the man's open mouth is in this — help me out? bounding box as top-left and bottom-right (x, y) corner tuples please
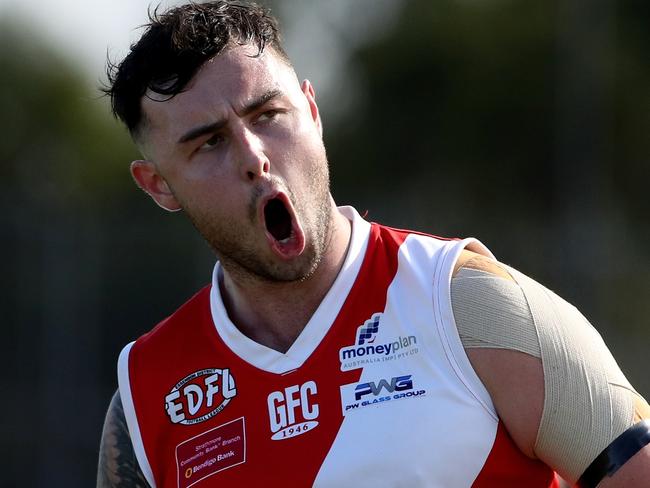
(185, 156), (333, 283)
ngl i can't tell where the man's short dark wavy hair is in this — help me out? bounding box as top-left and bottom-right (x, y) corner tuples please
(102, 0), (288, 136)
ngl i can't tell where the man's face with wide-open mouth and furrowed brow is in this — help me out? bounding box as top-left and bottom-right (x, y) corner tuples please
(132, 45), (333, 281)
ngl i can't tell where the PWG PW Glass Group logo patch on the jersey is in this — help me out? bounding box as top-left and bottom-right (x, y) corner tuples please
(341, 374), (426, 415)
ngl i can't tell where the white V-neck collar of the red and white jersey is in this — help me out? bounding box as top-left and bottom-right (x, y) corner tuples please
(210, 206), (370, 374)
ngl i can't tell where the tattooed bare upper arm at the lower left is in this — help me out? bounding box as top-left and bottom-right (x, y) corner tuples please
(97, 390), (149, 488)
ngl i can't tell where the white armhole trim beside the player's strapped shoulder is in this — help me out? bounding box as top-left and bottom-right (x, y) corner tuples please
(433, 238), (498, 419)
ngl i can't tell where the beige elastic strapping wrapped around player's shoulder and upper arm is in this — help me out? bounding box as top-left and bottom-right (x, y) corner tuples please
(451, 268), (645, 482)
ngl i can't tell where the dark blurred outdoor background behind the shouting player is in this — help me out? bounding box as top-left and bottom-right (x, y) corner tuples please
(0, 0), (650, 487)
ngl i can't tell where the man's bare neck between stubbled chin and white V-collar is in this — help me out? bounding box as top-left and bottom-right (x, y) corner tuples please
(220, 207), (351, 352)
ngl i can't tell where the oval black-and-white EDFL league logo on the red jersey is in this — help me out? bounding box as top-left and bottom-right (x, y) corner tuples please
(165, 368), (237, 425)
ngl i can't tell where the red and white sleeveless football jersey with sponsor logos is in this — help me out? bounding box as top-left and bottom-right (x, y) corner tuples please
(118, 207), (557, 488)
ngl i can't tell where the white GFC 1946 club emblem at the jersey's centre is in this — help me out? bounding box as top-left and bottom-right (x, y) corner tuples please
(266, 381), (319, 441)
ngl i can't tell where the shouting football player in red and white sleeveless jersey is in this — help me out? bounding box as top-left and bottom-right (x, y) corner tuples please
(98, 1), (650, 487)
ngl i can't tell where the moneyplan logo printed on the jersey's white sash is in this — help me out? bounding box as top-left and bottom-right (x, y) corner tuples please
(339, 313), (418, 371)
